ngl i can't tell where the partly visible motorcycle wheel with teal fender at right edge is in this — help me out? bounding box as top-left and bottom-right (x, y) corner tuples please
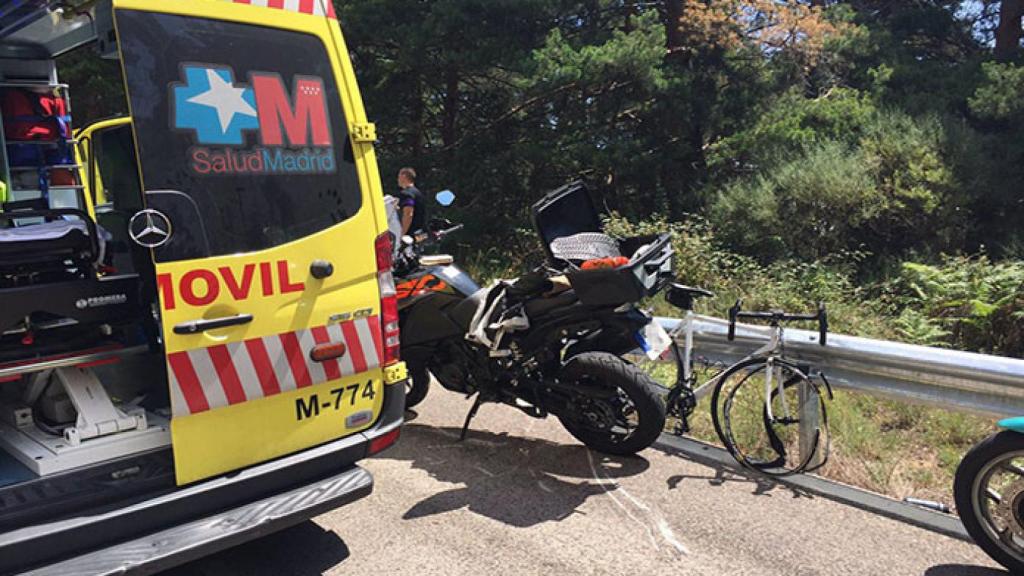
(953, 430), (1024, 574)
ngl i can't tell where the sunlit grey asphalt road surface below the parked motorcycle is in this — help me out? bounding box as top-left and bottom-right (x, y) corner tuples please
(167, 386), (1007, 576)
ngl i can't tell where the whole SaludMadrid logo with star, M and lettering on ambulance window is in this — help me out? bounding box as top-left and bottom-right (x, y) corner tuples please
(171, 64), (337, 175)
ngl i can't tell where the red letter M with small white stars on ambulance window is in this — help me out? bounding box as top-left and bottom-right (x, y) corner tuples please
(251, 73), (331, 147)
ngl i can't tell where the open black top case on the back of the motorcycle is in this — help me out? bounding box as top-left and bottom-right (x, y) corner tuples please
(532, 181), (673, 306)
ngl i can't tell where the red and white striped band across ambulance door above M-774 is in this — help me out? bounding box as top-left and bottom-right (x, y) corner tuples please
(167, 316), (382, 417)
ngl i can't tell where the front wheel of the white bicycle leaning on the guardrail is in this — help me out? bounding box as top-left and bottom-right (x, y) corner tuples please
(712, 358), (828, 477)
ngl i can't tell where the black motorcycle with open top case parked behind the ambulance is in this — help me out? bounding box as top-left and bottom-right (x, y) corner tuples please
(395, 182), (673, 454)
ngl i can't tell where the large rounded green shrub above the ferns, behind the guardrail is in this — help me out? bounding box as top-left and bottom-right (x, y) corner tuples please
(710, 112), (964, 261)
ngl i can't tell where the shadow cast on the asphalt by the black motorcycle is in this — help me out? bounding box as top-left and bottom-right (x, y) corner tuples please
(379, 423), (649, 528)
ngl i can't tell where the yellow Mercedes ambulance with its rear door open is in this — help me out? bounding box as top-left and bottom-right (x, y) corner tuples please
(0, 0), (407, 574)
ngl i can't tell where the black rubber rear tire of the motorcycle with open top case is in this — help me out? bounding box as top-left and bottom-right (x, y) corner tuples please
(559, 352), (666, 455)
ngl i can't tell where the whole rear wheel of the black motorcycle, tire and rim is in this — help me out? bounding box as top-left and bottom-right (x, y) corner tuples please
(559, 352), (666, 455)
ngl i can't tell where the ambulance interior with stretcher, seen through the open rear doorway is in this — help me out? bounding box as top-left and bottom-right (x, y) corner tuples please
(0, 0), (174, 522)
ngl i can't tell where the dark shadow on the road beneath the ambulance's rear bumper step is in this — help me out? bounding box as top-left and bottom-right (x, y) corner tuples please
(160, 522), (349, 576)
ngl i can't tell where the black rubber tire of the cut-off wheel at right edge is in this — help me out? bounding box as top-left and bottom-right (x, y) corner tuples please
(953, 430), (1024, 574)
